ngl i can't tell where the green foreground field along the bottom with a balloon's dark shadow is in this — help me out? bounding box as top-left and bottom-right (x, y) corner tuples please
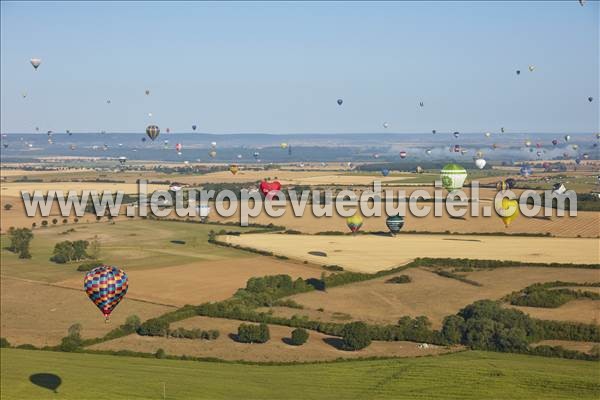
(1, 349), (600, 400)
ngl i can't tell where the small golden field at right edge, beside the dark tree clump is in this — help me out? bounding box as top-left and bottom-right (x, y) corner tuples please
(510, 302), (600, 324)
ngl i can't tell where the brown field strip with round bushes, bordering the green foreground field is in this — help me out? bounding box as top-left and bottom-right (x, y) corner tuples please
(90, 317), (459, 362)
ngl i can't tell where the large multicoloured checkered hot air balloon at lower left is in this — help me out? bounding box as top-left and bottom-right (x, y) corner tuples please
(83, 265), (128, 321)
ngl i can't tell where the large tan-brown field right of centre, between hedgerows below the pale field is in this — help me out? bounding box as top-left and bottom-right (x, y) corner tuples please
(290, 267), (598, 328)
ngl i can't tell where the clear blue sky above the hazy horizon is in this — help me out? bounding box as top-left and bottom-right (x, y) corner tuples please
(0, 0), (600, 133)
